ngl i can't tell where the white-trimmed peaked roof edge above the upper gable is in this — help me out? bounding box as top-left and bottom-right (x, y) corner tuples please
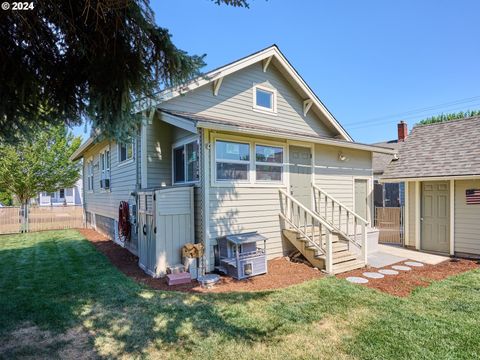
(137, 45), (353, 141)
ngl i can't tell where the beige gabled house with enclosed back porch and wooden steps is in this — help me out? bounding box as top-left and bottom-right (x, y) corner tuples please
(72, 46), (393, 275)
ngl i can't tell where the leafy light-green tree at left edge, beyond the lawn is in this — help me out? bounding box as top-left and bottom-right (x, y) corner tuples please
(0, 125), (81, 204)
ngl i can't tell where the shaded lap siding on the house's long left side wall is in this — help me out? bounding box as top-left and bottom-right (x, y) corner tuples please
(83, 141), (137, 220)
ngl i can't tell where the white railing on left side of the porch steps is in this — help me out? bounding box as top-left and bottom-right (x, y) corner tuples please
(279, 189), (334, 273)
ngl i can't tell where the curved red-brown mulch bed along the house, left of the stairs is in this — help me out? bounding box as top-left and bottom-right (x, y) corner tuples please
(79, 229), (323, 292)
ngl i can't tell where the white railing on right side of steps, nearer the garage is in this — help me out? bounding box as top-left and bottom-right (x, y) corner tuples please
(312, 184), (368, 263)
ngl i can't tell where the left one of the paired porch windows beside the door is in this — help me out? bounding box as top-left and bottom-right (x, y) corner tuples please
(215, 140), (250, 182)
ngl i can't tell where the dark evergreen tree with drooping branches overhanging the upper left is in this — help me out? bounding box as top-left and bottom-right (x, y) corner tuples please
(0, 0), (248, 142)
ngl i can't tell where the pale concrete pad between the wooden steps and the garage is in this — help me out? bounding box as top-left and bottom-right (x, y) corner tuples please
(368, 244), (450, 268)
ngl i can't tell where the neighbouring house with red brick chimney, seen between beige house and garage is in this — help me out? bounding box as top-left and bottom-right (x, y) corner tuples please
(372, 121), (408, 207)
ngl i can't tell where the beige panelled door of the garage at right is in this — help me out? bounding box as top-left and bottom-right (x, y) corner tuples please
(420, 181), (450, 253)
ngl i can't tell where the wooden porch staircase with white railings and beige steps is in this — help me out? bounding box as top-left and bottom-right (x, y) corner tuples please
(279, 189), (366, 274)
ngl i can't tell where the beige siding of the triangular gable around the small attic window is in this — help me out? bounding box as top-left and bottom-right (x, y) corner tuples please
(160, 63), (335, 137)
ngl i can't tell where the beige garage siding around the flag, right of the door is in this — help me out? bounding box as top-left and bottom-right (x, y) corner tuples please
(455, 180), (480, 255)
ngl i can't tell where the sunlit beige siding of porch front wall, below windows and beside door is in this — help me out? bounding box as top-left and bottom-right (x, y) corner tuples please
(204, 131), (373, 264)
